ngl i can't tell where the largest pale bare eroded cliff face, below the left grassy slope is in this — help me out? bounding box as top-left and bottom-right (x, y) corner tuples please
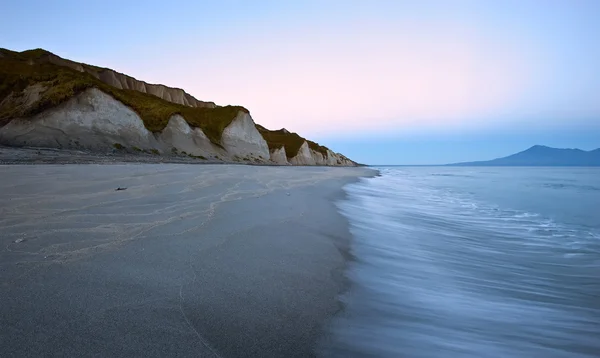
(0, 88), (269, 162)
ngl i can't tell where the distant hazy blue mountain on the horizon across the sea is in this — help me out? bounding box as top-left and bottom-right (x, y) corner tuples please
(448, 145), (600, 167)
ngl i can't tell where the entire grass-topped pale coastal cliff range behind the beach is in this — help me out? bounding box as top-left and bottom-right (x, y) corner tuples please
(0, 49), (356, 166)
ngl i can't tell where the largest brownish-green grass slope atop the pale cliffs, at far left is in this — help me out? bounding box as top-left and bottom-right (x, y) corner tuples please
(0, 49), (248, 145)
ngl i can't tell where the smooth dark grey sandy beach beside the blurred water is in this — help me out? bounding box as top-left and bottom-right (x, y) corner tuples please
(0, 164), (372, 357)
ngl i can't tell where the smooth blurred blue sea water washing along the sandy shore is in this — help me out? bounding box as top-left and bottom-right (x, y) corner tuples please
(322, 167), (600, 357)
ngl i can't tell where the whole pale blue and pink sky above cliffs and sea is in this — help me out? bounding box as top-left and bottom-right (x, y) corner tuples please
(0, 0), (600, 164)
